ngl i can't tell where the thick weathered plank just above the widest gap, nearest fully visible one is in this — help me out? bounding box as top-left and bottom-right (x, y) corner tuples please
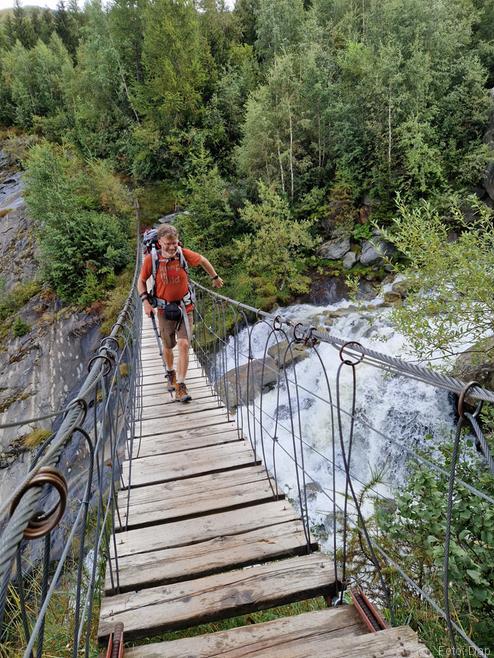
(98, 554), (334, 638)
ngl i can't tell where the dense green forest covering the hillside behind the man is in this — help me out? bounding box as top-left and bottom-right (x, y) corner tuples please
(0, 0), (494, 342)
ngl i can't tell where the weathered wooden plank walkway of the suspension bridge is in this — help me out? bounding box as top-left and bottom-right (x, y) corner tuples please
(98, 318), (427, 658)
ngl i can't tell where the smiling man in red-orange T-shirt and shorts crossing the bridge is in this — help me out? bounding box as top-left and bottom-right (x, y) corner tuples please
(137, 224), (223, 402)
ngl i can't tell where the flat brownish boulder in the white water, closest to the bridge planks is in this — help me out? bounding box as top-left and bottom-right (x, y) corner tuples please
(217, 356), (279, 407)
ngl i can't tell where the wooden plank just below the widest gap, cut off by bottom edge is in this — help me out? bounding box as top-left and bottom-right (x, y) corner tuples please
(125, 606), (372, 658)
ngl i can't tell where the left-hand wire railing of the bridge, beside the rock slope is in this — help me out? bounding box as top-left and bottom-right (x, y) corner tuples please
(0, 211), (142, 658)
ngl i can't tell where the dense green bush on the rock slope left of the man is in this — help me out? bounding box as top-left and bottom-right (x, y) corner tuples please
(26, 144), (129, 303)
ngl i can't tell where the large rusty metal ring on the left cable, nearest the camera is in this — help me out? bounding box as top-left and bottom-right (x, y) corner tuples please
(10, 466), (68, 539)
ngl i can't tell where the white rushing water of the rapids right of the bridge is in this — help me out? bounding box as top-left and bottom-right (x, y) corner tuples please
(215, 297), (454, 544)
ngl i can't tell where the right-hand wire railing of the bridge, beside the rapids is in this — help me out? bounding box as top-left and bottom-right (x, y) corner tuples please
(191, 284), (494, 657)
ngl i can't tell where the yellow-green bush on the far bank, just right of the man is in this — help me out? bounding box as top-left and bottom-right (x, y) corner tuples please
(235, 183), (315, 307)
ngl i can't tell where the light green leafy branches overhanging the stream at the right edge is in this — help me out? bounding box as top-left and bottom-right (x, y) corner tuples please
(386, 197), (494, 356)
